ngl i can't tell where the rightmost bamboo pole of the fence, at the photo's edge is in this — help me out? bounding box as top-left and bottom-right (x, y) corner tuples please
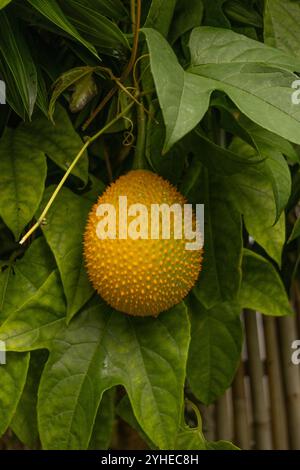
(278, 316), (300, 450)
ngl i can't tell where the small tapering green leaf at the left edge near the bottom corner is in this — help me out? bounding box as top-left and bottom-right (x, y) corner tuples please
(0, 353), (30, 436)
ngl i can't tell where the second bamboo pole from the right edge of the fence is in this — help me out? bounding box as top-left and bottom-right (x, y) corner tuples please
(264, 316), (289, 450)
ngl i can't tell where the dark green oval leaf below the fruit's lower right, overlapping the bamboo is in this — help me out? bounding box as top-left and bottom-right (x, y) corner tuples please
(187, 298), (243, 404)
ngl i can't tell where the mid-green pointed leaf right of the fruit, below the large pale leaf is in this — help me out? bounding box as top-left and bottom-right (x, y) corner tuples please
(224, 139), (290, 265)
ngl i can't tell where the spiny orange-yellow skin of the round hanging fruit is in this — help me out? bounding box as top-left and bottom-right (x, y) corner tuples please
(84, 170), (202, 316)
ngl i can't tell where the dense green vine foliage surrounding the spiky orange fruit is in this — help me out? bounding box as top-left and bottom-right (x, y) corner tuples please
(0, 0), (300, 449)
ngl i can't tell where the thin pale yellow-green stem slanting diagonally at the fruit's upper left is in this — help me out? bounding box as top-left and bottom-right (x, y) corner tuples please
(19, 101), (134, 245)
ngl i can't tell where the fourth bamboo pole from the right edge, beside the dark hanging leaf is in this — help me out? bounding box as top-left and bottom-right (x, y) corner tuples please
(232, 361), (251, 450)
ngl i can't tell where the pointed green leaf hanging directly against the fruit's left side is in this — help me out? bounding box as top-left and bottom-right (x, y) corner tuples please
(38, 186), (94, 321)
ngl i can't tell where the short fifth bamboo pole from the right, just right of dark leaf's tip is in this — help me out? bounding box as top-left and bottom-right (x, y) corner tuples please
(216, 390), (233, 441)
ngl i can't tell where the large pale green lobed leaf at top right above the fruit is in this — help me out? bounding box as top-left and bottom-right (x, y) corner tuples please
(143, 27), (300, 151)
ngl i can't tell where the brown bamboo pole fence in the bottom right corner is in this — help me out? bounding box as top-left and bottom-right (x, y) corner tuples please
(200, 302), (300, 450)
